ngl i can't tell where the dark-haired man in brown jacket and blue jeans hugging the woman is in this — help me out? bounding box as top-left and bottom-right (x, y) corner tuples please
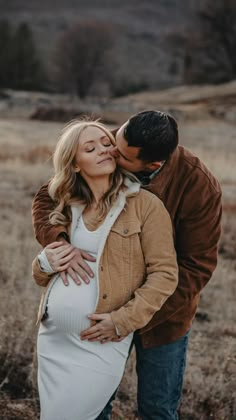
(33, 111), (221, 420)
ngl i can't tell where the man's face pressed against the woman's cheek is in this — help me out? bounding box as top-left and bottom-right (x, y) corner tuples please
(111, 123), (150, 172)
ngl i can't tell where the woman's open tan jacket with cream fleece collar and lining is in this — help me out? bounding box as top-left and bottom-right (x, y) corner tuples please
(33, 181), (178, 336)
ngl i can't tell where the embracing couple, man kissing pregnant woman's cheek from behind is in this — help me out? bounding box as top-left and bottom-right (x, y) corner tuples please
(33, 110), (221, 420)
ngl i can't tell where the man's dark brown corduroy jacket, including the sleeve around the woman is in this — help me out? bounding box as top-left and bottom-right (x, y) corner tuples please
(33, 146), (222, 347)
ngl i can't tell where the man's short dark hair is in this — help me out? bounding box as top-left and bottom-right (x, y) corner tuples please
(124, 111), (179, 162)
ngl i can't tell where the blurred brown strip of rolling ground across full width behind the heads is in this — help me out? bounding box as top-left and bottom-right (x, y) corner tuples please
(0, 80), (236, 125)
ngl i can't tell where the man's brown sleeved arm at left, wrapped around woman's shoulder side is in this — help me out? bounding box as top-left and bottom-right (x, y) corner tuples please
(32, 183), (66, 247)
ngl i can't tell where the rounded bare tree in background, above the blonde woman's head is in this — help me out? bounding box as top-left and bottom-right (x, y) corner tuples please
(52, 21), (114, 98)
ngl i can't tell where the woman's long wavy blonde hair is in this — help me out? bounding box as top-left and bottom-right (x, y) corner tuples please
(48, 118), (137, 226)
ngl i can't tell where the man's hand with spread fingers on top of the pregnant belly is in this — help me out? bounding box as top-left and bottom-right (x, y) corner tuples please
(61, 247), (96, 286)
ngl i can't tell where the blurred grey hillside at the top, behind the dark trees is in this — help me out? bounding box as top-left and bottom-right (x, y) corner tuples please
(0, 0), (193, 89)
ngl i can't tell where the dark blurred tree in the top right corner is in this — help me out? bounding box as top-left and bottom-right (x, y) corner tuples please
(184, 0), (236, 83)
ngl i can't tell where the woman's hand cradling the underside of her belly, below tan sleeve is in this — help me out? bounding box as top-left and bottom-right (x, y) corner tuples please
(80, 314), (124, 343)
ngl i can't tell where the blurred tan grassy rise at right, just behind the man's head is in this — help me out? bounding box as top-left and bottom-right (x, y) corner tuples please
(110, 80), (236, 123)
